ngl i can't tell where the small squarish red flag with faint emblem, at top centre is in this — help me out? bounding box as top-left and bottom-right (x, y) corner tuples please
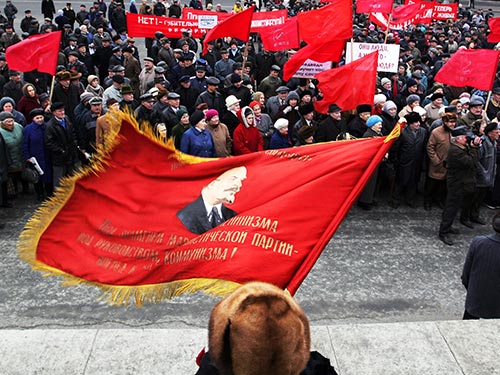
(260, 17), (300, 51)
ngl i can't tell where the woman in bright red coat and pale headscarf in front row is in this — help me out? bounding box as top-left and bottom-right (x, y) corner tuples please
(233, 107), (264, 155)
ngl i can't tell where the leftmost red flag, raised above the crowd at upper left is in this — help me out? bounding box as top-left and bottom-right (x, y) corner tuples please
(5, 31), (62, 75)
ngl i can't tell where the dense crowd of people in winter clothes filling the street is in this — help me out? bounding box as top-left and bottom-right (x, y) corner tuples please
(0, 0), (500, 245)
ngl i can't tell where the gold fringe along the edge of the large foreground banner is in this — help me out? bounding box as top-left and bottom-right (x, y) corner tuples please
(17, 111), (240, 307)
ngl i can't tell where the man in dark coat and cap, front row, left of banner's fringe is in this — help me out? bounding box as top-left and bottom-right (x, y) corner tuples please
(45, 102), (79, 186)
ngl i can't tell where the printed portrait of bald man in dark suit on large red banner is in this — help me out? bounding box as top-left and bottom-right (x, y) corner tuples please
(177, 167), (247, 234)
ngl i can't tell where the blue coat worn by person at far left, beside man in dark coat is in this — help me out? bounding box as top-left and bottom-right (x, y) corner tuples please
(23, 122), (52, 182)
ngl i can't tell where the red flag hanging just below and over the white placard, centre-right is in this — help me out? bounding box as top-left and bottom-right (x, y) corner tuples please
(314, 51), (378, 113)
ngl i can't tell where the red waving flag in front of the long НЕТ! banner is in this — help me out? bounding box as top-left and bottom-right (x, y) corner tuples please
(203, 7), (254, 54)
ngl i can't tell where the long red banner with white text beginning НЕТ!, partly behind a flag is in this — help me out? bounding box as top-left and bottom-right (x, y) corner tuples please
(127, 8), (287, 38)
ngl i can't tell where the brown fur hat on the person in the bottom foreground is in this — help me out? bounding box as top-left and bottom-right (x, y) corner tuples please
(208, 282), (311, 375)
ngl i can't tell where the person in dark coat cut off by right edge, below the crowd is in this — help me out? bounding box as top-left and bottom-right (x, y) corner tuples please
(462, 213), (500, 319)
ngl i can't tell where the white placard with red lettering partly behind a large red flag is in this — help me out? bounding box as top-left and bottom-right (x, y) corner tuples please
(345, 42), (399, 73)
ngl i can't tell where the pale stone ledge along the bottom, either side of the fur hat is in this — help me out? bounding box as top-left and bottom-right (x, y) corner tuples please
(0, 320), (500, 375)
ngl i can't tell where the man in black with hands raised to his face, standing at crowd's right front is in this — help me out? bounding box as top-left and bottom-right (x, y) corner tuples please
(439, 126), (480, 246)
